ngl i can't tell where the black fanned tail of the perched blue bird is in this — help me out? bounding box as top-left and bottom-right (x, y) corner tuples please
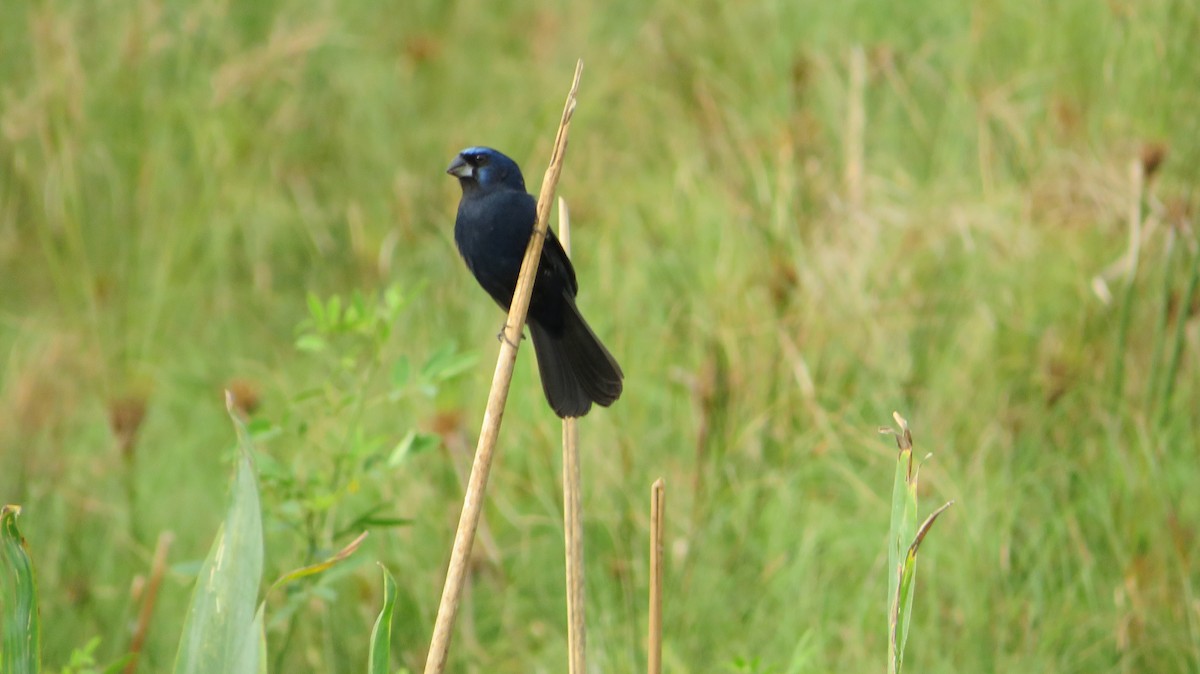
(529, 301), (624, 417)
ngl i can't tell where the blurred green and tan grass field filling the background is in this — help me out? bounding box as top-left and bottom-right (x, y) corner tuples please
(0, 0), (1200, 674)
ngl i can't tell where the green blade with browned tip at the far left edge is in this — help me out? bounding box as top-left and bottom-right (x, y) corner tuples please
(0, 505), (42, 674)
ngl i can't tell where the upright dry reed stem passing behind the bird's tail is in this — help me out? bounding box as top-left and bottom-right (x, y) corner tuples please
(558, 197), (588, 674)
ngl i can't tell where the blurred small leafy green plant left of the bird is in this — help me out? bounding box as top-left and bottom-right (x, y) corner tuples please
(250, 287), (475, 562)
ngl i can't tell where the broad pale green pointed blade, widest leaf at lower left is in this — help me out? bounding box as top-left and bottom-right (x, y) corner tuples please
(174, 400), (265, 674)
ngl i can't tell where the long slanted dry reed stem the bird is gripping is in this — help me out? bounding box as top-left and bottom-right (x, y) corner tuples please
(425, 60), (583, 674)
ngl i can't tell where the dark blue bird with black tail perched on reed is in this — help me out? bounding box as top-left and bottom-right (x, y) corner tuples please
(446, 148), (624, 419)
